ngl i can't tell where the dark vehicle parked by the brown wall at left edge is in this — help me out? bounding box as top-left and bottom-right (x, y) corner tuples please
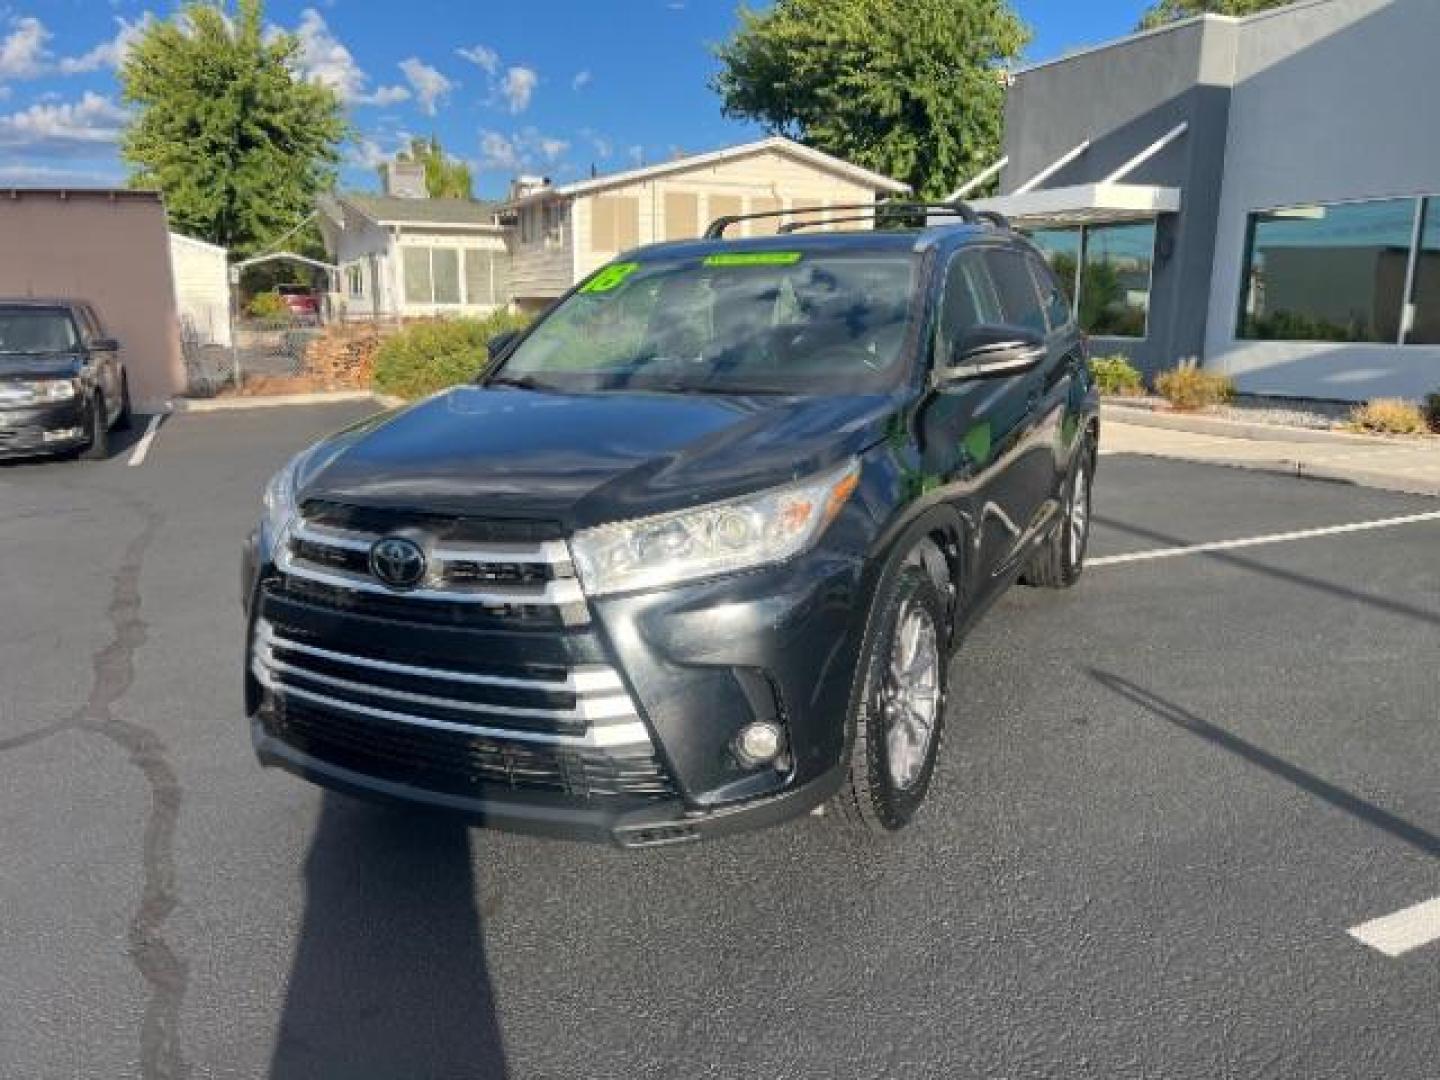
(0, 298), (130, 458)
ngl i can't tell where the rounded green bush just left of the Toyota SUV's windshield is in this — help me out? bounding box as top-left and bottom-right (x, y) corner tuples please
(374, 311), (528, 397)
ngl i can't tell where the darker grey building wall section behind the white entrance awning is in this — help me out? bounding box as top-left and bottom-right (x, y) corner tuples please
(1001, 20), (1234, 372)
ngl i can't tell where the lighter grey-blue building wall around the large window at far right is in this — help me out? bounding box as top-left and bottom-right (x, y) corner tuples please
(1205, 0), (1440, 399)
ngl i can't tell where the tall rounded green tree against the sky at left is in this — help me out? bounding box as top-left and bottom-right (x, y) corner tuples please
(120, 0), (350, 255)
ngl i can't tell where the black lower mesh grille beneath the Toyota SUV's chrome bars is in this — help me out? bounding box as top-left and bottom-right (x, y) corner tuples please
(265, 704), (675, 799)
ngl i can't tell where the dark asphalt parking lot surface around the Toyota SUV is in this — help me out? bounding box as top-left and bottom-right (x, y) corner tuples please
(0, 406), (1440, 1080)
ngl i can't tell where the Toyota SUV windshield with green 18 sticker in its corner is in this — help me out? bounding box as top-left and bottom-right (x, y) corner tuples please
(494, 251), (914, 393)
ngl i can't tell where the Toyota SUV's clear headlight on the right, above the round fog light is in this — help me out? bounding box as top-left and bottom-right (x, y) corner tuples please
(570, 461), (860, 596)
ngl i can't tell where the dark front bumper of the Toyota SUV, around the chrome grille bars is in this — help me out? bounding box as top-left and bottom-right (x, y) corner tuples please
(243, 529), (864, 847)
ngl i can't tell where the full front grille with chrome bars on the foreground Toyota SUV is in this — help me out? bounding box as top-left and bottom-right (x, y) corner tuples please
(251, 501), (674, 798)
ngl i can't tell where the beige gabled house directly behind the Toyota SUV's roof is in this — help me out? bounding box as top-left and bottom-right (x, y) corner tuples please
(500, 137), (909, 308)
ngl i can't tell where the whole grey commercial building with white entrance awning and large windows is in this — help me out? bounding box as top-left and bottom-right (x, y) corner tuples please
(979, 0), (1440, 400)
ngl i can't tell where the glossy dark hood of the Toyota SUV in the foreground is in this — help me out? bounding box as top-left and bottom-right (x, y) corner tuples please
(298, 386), (899, 528)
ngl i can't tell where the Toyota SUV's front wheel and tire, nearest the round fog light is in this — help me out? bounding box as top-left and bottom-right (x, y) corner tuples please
(835, 566), (948, 835)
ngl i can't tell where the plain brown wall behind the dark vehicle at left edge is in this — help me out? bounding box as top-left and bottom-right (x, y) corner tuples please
(0, 190), (184, 409)
